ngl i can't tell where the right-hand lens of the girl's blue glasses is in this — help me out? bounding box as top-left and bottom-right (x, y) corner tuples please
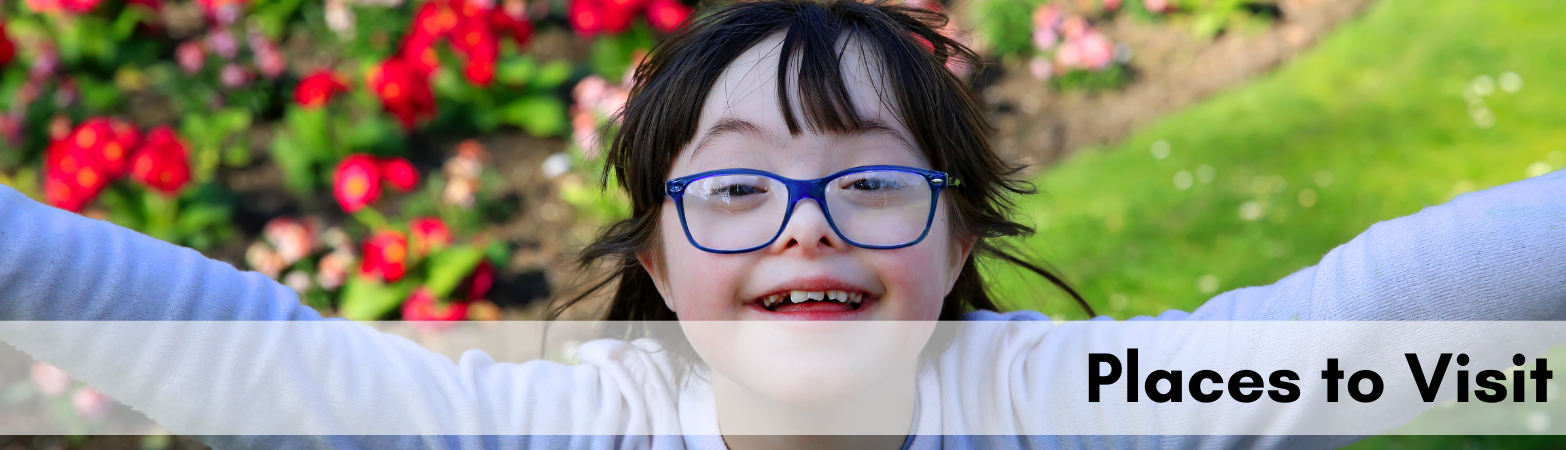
(827, 171), (933, 246)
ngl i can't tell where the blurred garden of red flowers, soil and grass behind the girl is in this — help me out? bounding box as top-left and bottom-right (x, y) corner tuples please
(0, 0), (1566, 448)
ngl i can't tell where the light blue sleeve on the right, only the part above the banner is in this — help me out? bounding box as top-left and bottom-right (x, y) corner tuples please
(1160, 171), (1566, 320)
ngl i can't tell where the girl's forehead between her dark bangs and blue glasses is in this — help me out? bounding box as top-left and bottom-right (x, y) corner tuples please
(677, 31), (926, 169)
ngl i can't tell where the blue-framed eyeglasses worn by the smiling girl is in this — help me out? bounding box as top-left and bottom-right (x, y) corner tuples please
(664, 166), (957, 254)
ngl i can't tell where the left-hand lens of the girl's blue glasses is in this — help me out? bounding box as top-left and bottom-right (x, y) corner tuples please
(683, 174), (788, 251)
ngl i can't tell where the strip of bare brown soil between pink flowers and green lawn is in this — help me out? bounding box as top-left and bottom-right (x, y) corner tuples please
(983, 0), (1373, 168)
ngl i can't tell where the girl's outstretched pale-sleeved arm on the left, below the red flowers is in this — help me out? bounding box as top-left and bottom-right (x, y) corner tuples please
(0, 187), (678, 447)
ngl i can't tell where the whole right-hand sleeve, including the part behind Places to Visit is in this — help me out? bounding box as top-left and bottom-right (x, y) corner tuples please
(938, 171), (1566, 448)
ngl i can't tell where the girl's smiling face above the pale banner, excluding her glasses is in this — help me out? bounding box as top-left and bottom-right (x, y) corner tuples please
(640, 33), (972, 321)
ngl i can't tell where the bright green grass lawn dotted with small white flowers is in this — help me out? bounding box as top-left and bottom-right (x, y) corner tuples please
(993, 0), (1566, 448)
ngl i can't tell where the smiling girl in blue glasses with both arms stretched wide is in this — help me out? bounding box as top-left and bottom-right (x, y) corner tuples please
(0, 0), (1566, 448)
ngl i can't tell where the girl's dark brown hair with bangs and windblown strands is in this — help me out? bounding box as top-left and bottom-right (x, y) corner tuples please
(547, 0), (1093, 321)
